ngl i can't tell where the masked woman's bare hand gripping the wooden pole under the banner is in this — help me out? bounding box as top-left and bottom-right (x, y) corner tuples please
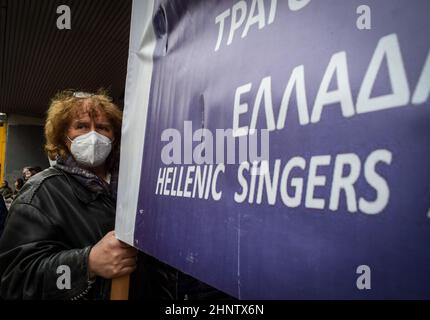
(88, 231), (137, 279)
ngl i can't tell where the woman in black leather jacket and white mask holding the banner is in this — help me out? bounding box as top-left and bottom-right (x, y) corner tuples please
(0, 92), (137, 299)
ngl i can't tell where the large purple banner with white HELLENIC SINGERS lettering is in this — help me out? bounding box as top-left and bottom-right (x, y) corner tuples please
(116, 0), (430, 299)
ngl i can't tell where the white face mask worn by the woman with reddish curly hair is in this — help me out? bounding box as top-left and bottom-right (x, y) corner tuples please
(67, 131), (112, 167)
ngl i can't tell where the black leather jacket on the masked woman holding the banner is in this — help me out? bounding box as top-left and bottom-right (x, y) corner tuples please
(0, 167), (115, 299)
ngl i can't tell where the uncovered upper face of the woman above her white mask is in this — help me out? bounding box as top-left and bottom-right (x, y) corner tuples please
(66, 100), (114, 150)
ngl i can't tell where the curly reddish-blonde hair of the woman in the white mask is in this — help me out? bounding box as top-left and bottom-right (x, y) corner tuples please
(45, 89), (122, 165)
